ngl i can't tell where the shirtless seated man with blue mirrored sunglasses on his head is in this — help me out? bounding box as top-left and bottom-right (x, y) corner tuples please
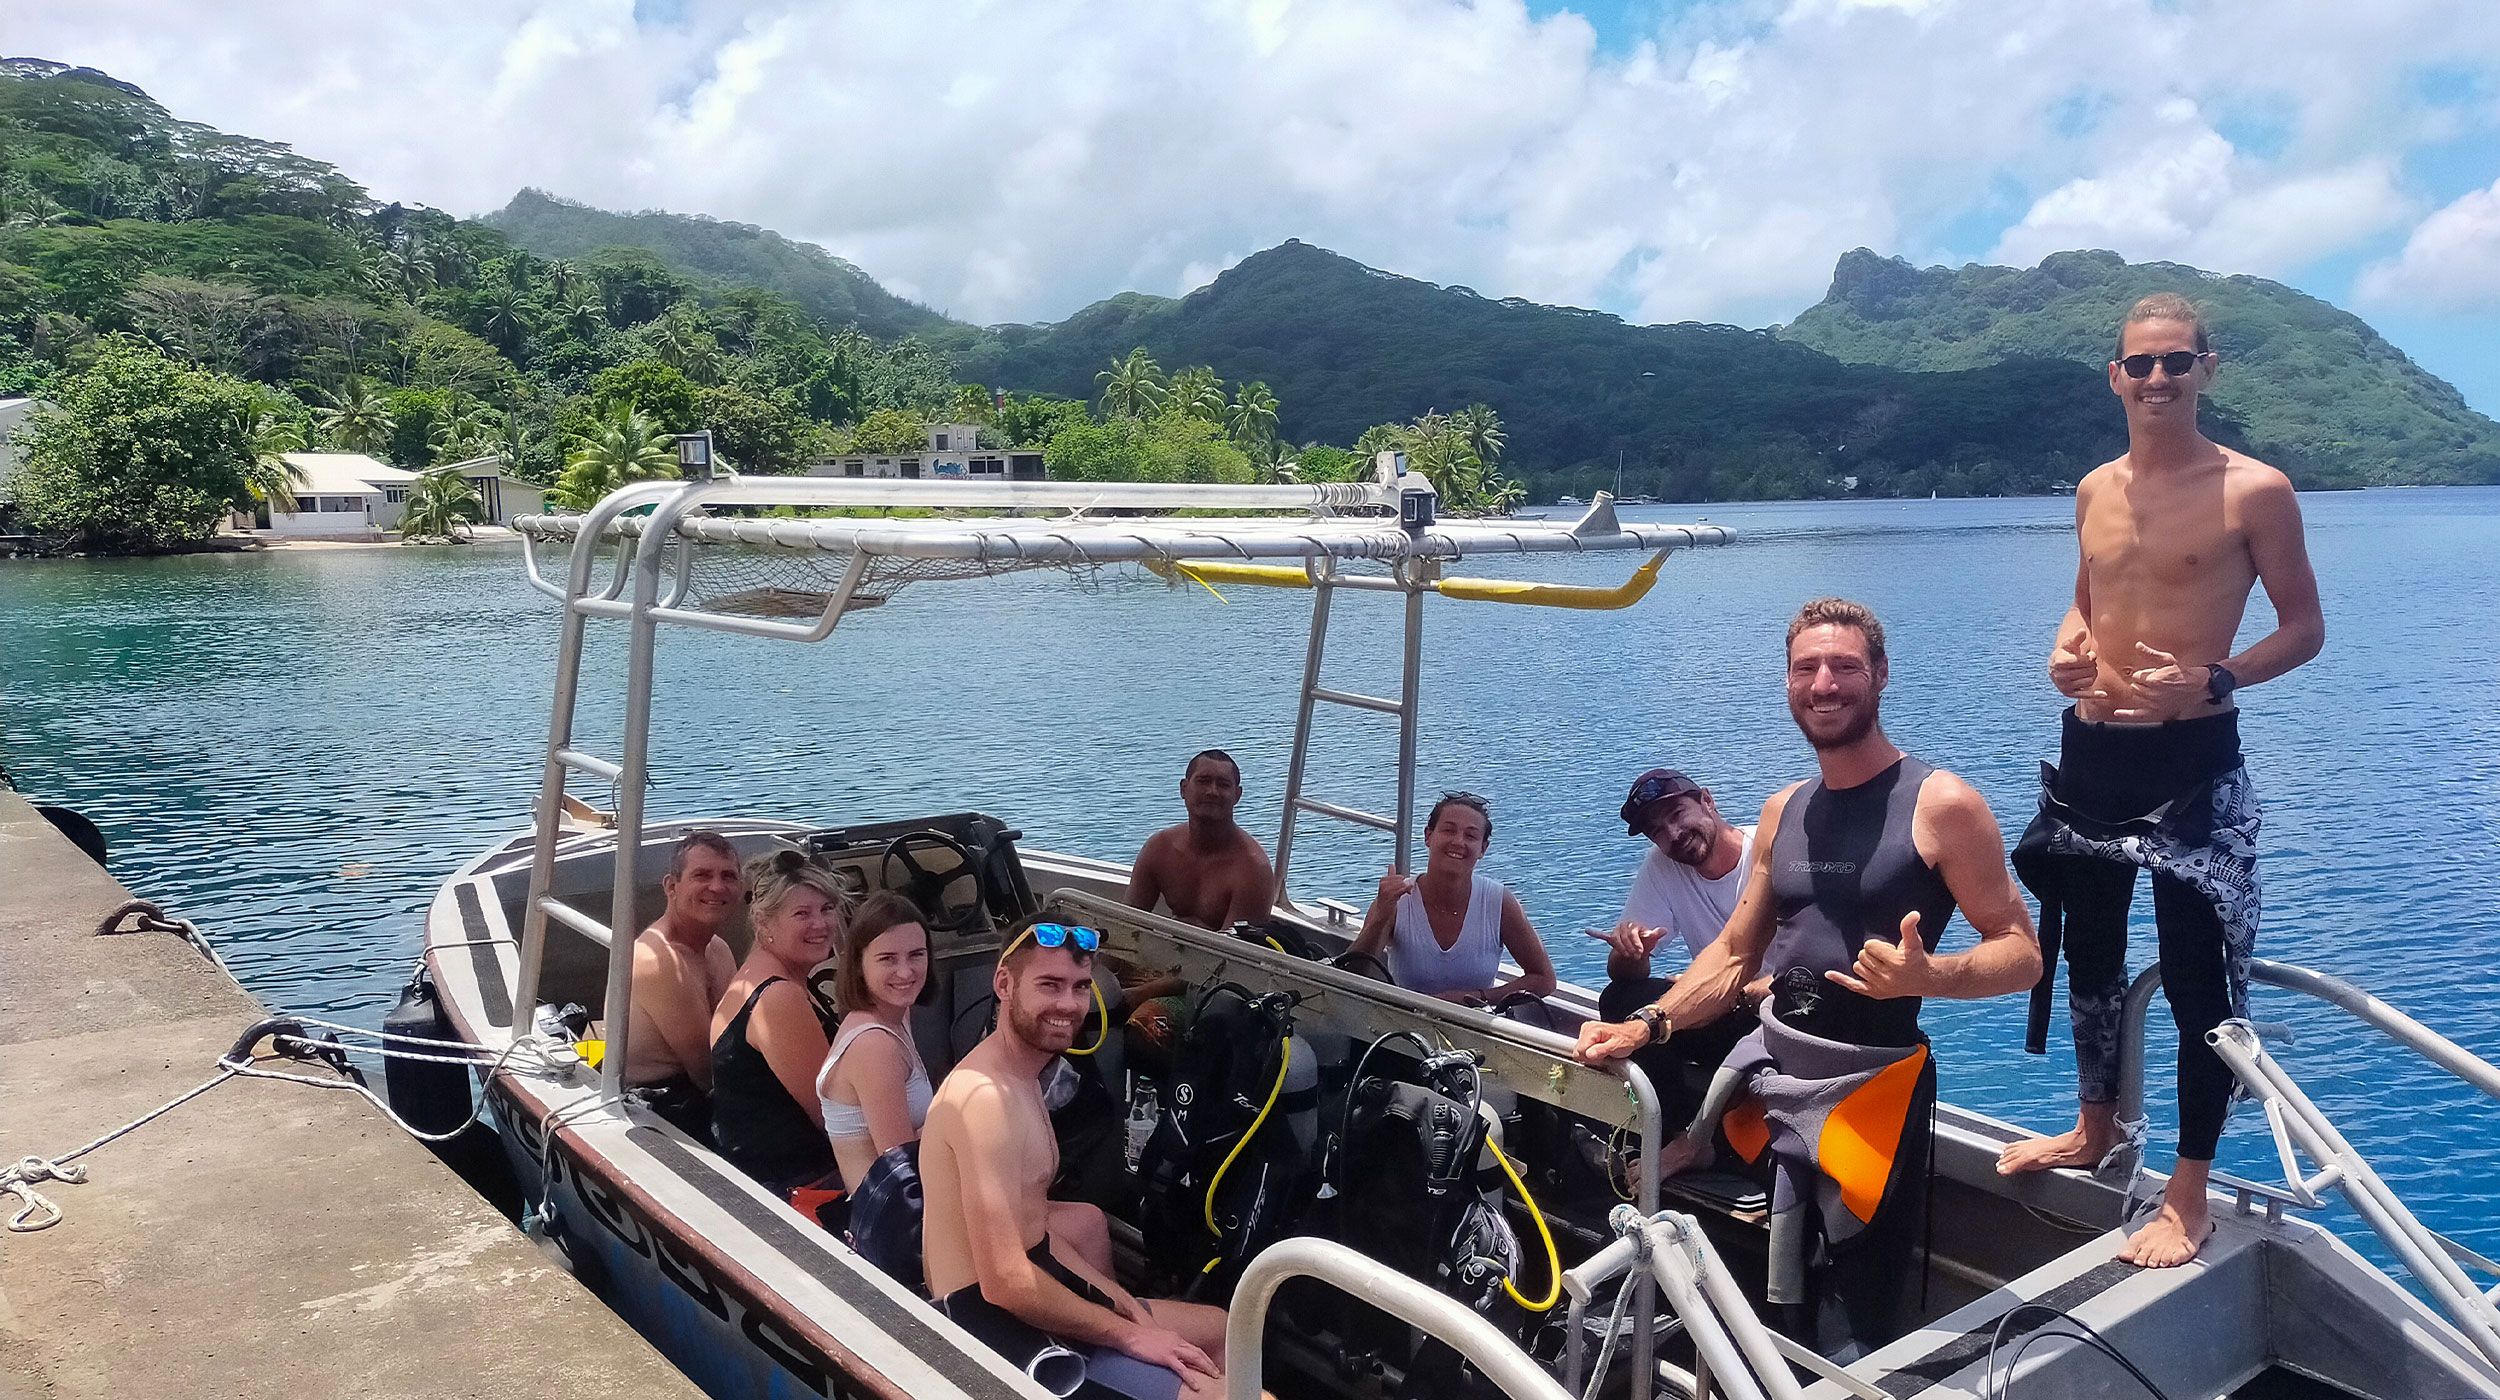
(920, 923), (1225, 1400)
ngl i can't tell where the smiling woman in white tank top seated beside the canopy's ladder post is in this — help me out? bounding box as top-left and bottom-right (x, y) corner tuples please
(1350, 793), (1555, 1005)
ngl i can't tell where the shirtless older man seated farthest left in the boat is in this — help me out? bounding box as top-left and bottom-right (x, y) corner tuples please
(625, 830), (748, 1143)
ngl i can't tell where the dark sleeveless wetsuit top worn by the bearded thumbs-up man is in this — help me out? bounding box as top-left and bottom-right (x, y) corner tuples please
(1763, 755), (1953, 1045)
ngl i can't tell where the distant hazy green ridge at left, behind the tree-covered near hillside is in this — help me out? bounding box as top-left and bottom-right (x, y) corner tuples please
(483, 190), (978, 345)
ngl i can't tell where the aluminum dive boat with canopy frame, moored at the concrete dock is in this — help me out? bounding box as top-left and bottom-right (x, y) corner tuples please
(410, 460), (2500, 1400)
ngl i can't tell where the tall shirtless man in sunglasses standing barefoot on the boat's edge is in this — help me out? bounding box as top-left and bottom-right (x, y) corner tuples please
(1998, 295), (2325, 1268)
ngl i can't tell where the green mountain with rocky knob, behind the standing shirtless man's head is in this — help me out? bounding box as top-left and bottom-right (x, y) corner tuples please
(1778, 248), (2500, 485)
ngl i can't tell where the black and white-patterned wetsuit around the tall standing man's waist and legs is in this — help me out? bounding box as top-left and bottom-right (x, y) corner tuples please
(2013, 710), (2260, 1160)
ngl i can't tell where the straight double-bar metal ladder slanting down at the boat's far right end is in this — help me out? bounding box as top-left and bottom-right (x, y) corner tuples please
(2205, 1015), (2500, 1365)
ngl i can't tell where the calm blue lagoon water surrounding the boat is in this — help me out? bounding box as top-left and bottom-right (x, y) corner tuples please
(0, 490), (2500, 1253)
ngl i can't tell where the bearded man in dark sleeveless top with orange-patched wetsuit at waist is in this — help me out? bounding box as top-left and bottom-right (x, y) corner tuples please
(1578, 598), (2040, 1345)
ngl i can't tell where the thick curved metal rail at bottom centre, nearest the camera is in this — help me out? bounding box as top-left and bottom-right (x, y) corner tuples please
(1225, 1235), (1575, 1400)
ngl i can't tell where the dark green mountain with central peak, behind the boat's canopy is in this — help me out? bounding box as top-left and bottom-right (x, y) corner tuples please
(955, 243), (2123, 500)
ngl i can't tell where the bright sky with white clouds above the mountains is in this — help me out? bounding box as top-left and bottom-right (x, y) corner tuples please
(5, 0), (2500, 323)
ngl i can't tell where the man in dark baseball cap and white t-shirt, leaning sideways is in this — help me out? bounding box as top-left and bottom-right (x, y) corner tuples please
(1588, 768), (1753, 1123)
